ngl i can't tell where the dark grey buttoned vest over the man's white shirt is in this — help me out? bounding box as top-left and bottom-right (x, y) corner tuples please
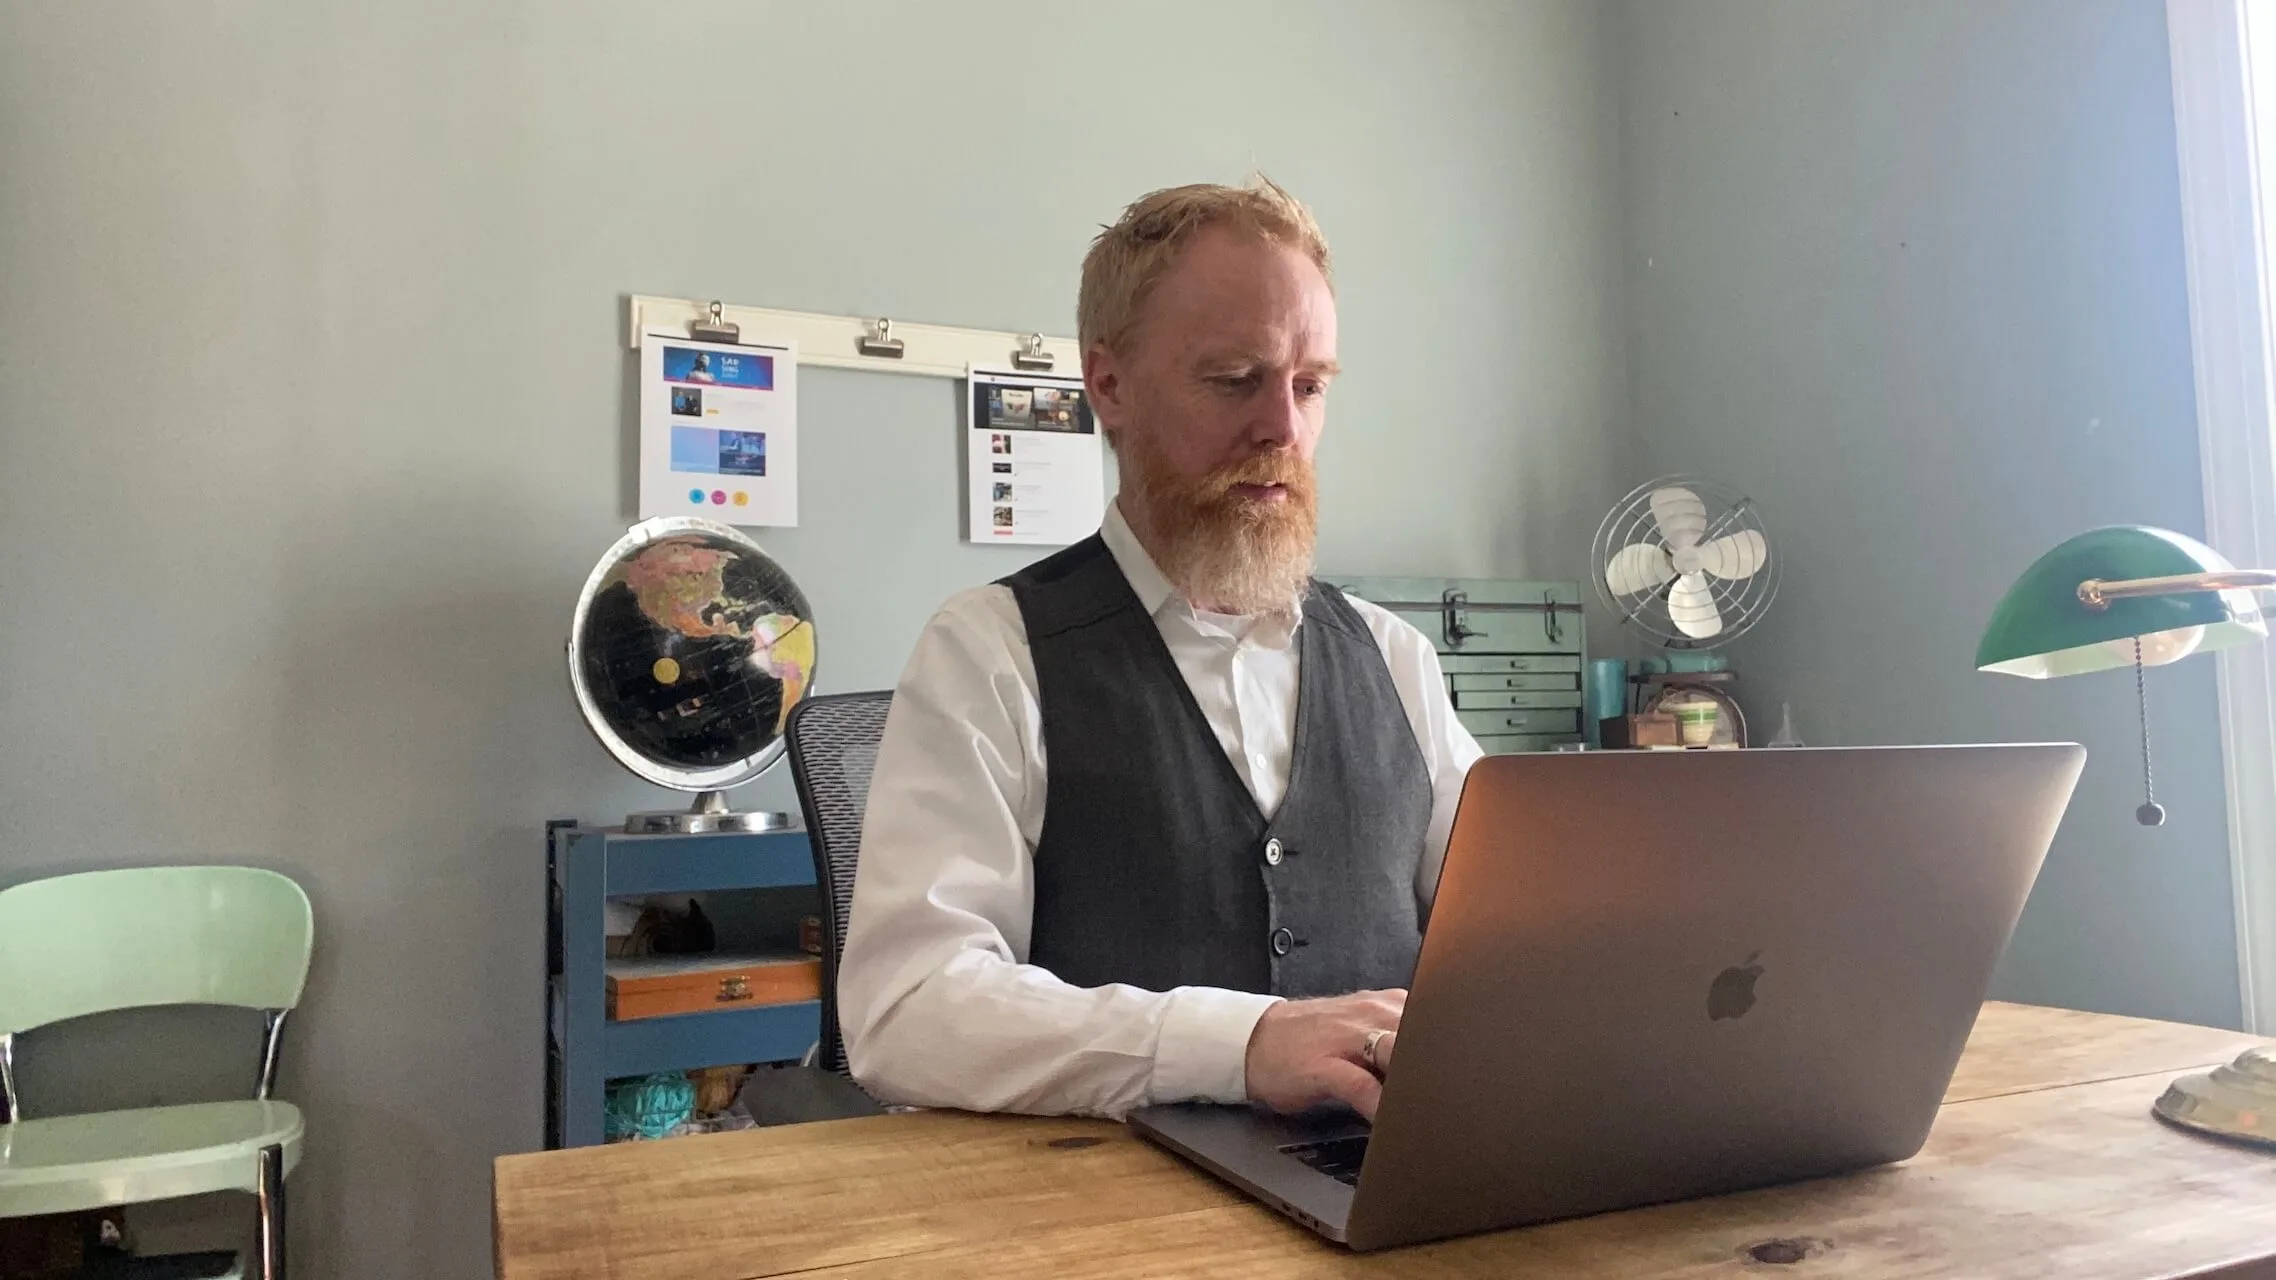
(1006, 535), (1432, 998)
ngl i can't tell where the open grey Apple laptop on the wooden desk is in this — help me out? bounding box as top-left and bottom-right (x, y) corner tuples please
(1131, 745), (2085, 1248)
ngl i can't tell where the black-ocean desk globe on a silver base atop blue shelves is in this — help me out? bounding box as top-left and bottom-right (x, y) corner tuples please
(569, 517), (815, 834)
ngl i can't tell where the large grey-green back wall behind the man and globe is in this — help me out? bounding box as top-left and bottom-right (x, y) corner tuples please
(0, 0), (1623, 1280)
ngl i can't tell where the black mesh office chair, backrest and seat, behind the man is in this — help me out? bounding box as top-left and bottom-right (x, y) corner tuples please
(742, 690), (892, 1125)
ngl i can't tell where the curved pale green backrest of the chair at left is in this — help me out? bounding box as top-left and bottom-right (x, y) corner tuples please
(0, 865), (316, 1036)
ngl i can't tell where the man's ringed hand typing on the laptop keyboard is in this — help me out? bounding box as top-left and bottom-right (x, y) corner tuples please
(1247, 988), (1407, 1121)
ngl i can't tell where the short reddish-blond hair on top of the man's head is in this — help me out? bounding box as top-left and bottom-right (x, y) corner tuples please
(1074, 173), (1336, 351)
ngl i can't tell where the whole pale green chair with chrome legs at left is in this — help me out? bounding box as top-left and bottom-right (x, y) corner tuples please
(0, 865), (314, 1280)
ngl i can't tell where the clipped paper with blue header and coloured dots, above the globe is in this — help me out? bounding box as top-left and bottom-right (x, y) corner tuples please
(640, 330), (799, 526)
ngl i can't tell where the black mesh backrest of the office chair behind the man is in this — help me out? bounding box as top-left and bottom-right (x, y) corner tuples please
(783, 690), (892, 1075)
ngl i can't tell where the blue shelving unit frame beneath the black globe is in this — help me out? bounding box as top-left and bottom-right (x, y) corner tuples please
(546, 822), (822, 1148)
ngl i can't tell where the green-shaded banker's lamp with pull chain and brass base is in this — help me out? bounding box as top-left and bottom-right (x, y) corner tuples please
(1976, 526), (2276, 1146)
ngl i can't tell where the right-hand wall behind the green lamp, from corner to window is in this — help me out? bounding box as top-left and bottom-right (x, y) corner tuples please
(1618, 0), (2240, 1025)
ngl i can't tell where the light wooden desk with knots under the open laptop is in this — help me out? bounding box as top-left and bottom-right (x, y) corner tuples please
(494, 1004), (2276, 1280)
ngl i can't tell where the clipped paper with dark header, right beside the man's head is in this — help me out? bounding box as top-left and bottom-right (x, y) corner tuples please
(965, 367), (1106, 547)
